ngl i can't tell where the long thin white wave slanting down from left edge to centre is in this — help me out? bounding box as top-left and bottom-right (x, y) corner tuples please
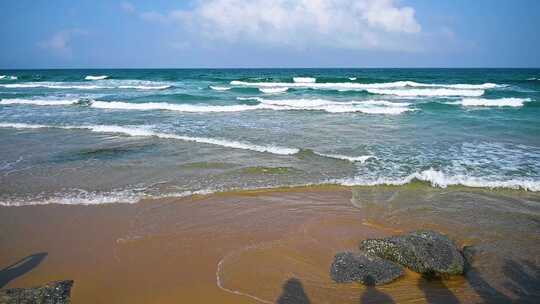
(0, 123), (300, 155)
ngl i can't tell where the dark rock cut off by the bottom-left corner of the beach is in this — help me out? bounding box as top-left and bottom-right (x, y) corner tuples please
(0, 281), (73, 304)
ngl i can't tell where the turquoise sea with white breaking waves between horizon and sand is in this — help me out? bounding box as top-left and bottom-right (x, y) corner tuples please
(0, 69), (540, 205)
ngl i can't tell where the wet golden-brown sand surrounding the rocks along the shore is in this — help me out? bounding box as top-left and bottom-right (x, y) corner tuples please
(0, 186), (540, 303)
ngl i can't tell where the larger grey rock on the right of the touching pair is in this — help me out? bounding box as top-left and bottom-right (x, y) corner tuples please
(360, 230), (464, 276)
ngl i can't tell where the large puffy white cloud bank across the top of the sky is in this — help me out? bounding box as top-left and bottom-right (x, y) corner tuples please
(127, 0), (421, 50)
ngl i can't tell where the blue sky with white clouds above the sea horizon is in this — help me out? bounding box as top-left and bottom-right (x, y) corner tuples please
(0, 0), (540, 69)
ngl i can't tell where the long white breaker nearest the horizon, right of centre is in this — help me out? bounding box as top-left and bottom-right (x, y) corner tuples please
(230, 80), (500, 91)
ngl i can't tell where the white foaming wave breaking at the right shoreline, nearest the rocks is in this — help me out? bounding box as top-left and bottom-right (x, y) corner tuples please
(332, 168), (540, 191)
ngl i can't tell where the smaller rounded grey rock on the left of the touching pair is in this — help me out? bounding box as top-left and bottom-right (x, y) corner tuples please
(330, 252), (404, 285)
